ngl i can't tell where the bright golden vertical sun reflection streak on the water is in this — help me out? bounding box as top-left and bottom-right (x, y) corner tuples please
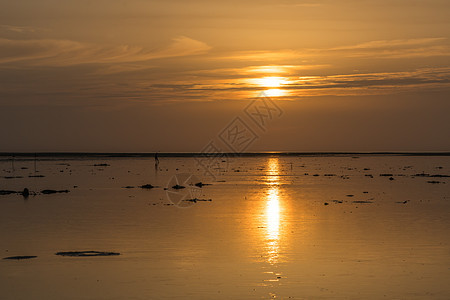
(266, 157), (281, 264)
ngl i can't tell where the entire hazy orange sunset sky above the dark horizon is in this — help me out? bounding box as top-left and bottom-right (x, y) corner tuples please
(0, 0), (450, 152)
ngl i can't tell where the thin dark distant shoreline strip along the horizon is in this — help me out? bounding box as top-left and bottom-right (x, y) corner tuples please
(0, 152), (450, 159)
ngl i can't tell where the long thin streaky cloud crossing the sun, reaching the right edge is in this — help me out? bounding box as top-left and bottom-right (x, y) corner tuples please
(147, 68), (450, 99)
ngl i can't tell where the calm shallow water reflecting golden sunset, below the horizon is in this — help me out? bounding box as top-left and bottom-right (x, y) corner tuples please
(0, 155), (450, 299)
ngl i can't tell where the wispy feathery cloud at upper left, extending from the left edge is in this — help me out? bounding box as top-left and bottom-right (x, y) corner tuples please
(0, 36), (211, 66)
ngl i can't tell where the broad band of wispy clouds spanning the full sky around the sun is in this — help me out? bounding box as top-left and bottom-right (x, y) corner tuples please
(0, 37), (450, 102)
